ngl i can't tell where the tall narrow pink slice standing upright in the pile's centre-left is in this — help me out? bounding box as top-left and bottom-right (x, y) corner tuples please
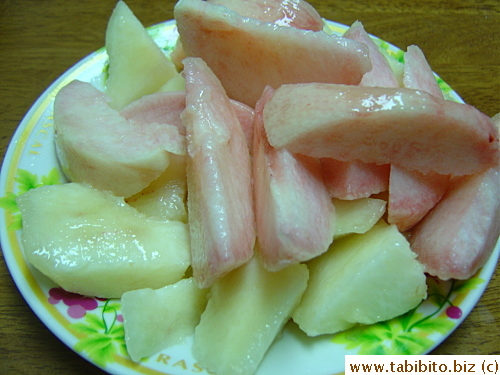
(181, 58), (255, 288)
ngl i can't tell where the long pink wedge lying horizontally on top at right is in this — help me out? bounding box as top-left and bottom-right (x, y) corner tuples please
(264, 83), (499, 175)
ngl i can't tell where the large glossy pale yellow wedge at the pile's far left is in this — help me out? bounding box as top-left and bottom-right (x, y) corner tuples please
(17, 183), (189, 298)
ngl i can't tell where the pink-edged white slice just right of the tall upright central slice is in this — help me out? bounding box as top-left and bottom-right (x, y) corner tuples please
(253, 87), (335, 271)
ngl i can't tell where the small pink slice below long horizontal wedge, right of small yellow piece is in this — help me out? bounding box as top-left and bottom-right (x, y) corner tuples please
(387, 164), (450, 232)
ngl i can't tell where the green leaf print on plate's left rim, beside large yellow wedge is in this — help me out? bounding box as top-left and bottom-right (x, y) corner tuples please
(0, 167), (61, 231)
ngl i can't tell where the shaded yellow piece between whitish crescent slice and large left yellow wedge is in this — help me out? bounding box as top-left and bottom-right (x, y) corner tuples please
(125, 154), (188, 223)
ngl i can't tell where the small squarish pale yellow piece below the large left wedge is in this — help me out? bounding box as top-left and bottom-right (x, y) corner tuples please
(122, 278), (208, 362)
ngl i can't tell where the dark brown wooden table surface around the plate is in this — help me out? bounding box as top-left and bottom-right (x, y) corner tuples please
(0, 0), (500, 375)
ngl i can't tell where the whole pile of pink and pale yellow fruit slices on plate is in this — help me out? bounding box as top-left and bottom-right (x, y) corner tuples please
(13, 0), (500, 375)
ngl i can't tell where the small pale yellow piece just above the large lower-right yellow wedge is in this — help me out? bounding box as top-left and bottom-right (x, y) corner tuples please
(333, 198), (386, 237)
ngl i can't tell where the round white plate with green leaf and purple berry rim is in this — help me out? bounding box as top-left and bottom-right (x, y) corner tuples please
(0, 21), (500, 375)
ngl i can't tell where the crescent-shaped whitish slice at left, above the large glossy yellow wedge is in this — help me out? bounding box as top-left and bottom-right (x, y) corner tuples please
(54, 80), (186, 197)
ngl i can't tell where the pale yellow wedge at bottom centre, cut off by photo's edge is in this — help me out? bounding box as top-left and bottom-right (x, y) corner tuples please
(193, 258), (308, 375)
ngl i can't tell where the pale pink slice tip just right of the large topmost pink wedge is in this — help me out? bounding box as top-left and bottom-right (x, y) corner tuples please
(344, 21), (399, 87)
